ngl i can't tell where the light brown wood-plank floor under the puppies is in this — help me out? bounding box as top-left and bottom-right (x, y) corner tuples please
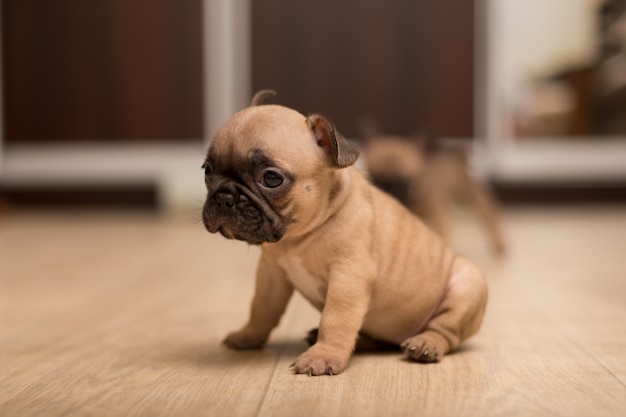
(0, 208), (626, 417)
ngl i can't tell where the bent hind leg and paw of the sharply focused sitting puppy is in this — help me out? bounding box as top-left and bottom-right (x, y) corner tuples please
(400, 257), (487, 362)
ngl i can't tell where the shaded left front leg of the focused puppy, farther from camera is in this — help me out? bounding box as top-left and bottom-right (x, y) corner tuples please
(224, 257), (294, 349)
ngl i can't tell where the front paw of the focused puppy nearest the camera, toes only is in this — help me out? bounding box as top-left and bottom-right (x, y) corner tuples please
(291, 344), (350, 376)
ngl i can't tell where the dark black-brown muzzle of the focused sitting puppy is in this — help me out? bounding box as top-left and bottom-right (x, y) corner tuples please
(202, 184), (286, 245)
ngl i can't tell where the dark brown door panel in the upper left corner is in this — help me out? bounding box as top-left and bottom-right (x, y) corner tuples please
(2, 0), (203, 143)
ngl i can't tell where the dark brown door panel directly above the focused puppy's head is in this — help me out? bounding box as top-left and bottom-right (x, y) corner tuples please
(252, 0), (474, 137)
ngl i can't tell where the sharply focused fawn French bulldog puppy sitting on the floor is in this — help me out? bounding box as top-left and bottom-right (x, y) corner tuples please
(202, 91), (487, 375)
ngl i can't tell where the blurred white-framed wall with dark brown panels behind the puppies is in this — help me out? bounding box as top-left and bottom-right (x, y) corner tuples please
(0, 0), (626, 210)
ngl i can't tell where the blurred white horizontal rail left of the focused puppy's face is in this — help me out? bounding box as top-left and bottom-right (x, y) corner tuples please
(0, 145), (206, 211)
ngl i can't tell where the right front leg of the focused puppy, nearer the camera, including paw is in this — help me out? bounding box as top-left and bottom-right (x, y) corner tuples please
(292, 268), (371, 375)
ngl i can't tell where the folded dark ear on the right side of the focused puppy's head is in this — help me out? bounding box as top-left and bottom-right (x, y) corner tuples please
(306, 114), (359, 168)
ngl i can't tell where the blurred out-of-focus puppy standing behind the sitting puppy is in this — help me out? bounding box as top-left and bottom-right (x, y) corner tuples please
(362, 131), (505, 255)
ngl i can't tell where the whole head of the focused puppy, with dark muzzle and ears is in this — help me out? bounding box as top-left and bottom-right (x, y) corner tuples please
(202, 93), (358, 244)
